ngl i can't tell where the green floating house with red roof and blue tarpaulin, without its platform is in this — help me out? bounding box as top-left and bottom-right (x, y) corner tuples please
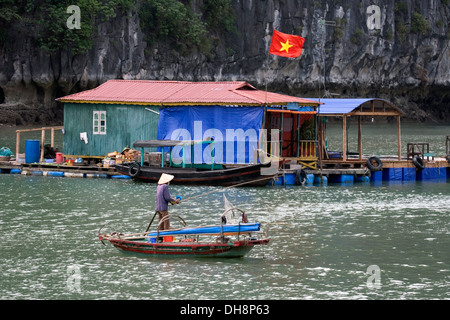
(57, 80), (320, 167)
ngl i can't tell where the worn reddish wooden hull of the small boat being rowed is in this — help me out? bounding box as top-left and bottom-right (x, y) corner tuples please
(99, 236), (269, 258)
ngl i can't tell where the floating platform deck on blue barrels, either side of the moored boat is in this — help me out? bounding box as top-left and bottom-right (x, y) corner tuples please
(0, 158), (450, 186)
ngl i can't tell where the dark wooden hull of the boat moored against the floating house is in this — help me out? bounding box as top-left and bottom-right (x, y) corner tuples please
(116, 163), (275, 187)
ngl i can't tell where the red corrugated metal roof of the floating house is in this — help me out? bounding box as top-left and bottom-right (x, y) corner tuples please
(57, 80), (318, 105)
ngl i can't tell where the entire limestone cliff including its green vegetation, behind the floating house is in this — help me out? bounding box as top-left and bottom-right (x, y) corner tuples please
(0, 0), (450, 122)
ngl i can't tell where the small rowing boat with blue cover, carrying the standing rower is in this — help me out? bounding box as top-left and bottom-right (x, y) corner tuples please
(98, 208), (269, 258)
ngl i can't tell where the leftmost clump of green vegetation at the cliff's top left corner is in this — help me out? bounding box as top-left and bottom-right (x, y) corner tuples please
(0, 0), (133, 54)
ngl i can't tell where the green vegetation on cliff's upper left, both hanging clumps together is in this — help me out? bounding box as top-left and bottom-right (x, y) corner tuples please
(0, 0), (234, 54)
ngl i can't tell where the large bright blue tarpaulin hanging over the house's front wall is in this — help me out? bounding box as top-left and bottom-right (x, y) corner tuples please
(157, 106), (264, 164)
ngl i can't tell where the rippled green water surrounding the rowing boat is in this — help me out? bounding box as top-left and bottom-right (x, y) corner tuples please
(0, 122), (450, 300)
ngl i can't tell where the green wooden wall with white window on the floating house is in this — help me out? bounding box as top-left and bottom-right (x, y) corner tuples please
(63, 103), (159, 156)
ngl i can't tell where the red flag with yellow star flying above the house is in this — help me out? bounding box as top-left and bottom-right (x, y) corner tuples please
(269, 30), (305, 58)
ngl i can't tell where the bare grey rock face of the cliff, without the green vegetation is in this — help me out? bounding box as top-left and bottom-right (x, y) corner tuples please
(0, 0), (450, 124)
